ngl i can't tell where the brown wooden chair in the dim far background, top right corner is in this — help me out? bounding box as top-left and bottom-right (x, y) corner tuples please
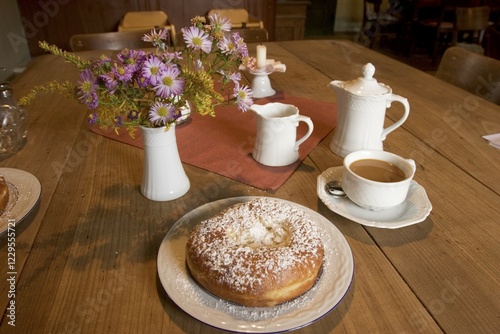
(453, 6), (490, 54)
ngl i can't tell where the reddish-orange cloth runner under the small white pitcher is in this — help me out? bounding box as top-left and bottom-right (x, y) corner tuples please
(91, 93), (337, 190)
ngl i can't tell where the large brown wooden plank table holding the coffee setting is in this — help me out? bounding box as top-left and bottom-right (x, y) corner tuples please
(0, 40), (500, 334)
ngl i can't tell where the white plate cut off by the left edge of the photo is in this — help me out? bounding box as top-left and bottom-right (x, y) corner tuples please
(0, 168), (42, 235)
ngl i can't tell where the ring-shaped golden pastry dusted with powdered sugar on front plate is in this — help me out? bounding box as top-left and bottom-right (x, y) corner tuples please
(186, 197), (324, 307)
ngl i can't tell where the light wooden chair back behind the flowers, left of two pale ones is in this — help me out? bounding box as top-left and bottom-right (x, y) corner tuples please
(118, 11), (176, 45)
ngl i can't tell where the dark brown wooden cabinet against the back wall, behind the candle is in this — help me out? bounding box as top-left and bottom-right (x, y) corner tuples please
(275, 0), (310, 41)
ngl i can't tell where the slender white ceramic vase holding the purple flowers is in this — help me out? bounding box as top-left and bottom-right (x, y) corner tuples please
(141, 124), (190, 201)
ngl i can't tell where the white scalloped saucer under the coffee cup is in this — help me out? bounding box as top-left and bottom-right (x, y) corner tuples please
(317, 166), (432, 229)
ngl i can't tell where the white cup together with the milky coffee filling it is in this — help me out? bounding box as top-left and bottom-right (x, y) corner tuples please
(342, 150), (416, 211)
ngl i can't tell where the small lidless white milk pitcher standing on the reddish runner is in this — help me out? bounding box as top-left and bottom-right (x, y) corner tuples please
(250, 102), (314, 167)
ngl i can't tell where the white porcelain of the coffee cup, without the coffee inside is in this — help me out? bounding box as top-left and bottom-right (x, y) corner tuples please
(342, 150), (416, 211)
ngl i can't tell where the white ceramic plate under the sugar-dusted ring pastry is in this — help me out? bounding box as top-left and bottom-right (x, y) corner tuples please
(157, 196), (354, 333)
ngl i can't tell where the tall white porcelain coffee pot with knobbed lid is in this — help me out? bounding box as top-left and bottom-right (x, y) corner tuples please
(329, 63), (410, 157)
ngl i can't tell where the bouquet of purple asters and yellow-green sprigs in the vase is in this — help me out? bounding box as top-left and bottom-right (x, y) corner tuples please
(19, 14), (255, 134)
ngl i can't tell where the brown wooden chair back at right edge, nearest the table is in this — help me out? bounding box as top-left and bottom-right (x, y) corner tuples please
(436, 46), (500, 105)
